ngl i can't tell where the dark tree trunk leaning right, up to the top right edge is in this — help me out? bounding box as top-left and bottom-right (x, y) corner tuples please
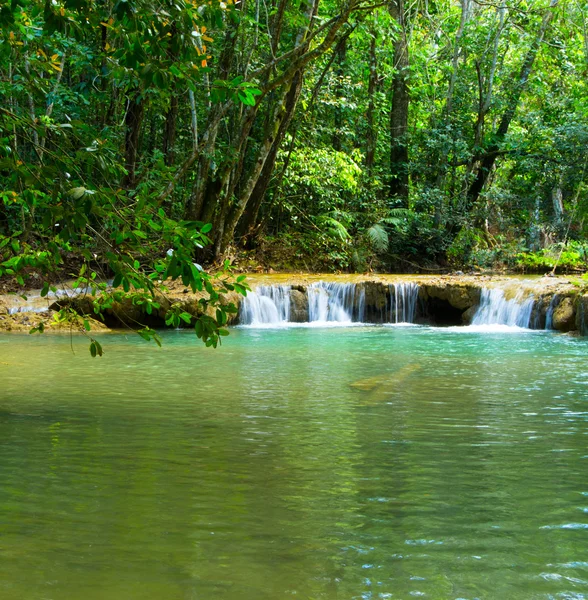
(467, 0), (559, 209)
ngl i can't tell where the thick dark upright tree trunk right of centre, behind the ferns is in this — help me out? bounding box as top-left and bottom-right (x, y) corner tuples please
(388, 0), (410, 208)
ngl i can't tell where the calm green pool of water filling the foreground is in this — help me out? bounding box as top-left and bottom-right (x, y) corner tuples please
(0, 327), (588, 600)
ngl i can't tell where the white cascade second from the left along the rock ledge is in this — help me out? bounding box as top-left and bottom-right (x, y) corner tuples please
(308, 281), (365, 323)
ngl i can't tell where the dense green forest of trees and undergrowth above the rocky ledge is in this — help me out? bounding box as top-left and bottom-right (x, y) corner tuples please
(0, 0), (588, 314)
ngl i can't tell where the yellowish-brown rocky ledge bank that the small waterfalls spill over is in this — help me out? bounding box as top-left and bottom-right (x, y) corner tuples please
(0, 273), (588, 334)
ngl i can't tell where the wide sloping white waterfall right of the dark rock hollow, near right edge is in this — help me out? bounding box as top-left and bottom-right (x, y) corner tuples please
(472, 288), (535, 328)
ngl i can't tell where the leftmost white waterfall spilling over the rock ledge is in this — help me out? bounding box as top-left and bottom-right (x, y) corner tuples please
(239, 285), (291, 325)
